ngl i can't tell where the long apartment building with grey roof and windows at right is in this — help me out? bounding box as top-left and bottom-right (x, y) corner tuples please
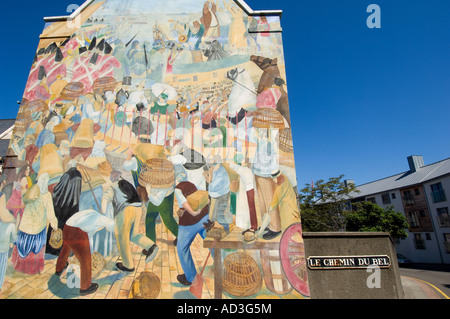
(352, 156), (450, 264)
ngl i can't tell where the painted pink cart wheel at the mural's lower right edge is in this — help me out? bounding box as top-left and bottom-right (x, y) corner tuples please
(280, 223), (310, 297)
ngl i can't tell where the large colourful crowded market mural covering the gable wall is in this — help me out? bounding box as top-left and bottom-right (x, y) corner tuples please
(0, 0), (309, 299)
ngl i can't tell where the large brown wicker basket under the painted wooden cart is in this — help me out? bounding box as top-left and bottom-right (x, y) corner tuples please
(223, 252), (262, 297)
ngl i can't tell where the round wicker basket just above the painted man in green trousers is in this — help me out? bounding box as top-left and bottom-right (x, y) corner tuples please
(138, 158), (175, 188)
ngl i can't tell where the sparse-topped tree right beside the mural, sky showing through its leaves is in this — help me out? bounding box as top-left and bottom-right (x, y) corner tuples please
(298, 175), (358, 232)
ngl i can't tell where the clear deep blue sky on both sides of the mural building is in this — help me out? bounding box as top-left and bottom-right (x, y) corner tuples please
(0, 0), (450, 187)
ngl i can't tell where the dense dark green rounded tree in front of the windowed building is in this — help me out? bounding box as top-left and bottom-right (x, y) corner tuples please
(346, 202), (409, 239)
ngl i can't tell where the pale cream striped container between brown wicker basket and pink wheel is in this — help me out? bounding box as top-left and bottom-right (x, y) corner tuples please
(260, 249), (293, 295)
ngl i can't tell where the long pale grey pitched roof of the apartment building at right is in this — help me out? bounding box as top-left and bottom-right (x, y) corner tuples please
(353, 158), (450, 197)
